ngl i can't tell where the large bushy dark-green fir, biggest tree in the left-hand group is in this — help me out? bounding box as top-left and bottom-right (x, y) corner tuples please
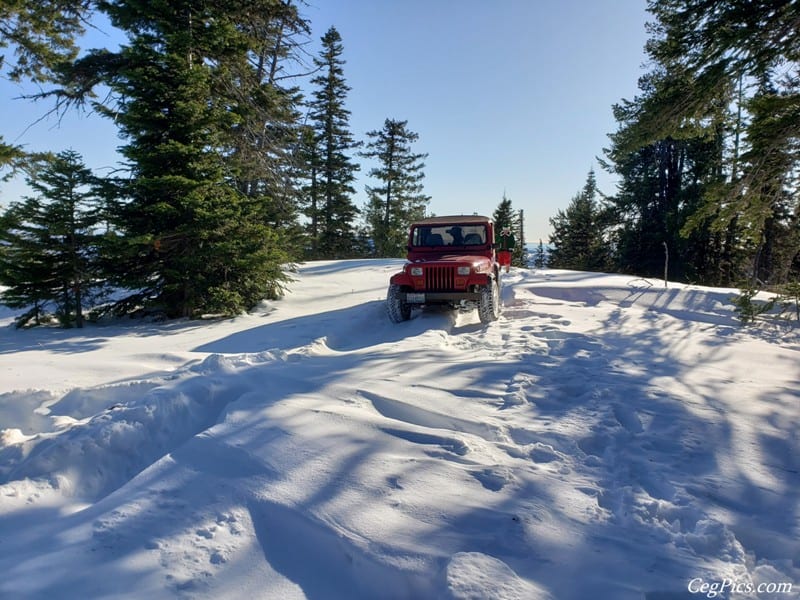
(57, 0), (294, 317)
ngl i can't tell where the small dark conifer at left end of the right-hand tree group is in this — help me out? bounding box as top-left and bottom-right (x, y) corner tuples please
(548, 170), (607, 271)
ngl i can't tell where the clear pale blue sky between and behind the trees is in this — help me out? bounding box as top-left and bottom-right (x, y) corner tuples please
(0, 0), (648, 242)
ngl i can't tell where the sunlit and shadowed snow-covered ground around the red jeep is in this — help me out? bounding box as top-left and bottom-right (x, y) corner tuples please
(0, 261), (800, 600)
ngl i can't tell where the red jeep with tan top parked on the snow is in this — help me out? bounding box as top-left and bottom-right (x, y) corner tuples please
(386, 216), (500, 323)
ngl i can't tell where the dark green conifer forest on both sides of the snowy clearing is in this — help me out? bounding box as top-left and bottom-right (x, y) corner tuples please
(0, 0), (800, 326)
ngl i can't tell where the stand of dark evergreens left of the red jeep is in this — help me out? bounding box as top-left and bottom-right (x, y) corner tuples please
(0, 0), (428, 325)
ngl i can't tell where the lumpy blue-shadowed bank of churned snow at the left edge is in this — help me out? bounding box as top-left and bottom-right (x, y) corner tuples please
(0, 353), (282, 500)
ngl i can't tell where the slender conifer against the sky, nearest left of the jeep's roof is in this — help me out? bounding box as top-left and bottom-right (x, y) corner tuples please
(361, 119), (430, 257)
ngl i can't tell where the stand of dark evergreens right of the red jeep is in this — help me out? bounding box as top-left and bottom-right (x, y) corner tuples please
(551, 0), (800, 286)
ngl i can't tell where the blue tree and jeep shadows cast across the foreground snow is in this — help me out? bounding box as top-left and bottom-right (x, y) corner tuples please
(0, 272), (800, 600)
